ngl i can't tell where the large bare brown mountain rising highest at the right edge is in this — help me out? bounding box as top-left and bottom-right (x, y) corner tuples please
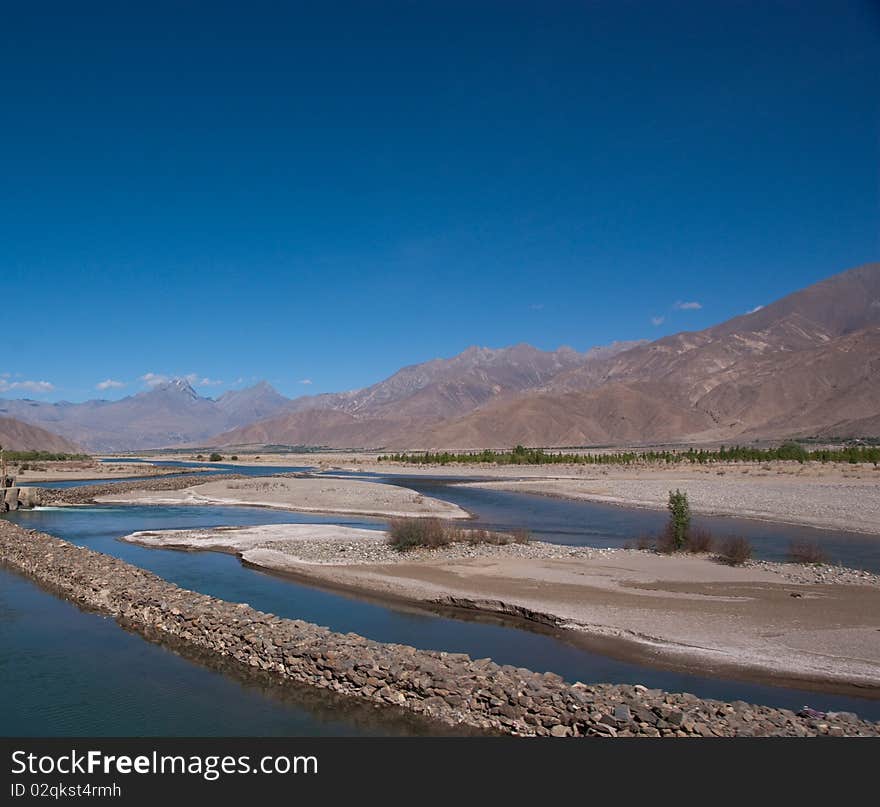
(416, 263), (880, 447)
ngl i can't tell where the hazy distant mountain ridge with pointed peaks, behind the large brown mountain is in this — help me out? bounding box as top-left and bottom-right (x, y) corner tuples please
(0, 342), (638, 452)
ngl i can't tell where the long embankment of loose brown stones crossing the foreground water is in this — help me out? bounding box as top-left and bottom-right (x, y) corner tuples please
(0, 522), (880, 737)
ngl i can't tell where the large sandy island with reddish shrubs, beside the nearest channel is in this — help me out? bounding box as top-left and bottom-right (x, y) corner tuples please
(123, 525), (880, 694)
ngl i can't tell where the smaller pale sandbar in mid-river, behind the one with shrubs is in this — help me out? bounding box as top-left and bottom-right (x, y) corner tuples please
(96, 477), (469, 519)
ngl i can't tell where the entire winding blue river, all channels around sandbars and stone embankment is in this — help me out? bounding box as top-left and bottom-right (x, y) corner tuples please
(0, 458), (880, 735)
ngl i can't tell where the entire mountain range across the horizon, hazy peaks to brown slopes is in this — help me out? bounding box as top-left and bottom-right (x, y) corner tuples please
(6, 263), (880, 452)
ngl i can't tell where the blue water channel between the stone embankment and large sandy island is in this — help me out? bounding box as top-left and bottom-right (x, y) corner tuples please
(9, 497), (880, 719)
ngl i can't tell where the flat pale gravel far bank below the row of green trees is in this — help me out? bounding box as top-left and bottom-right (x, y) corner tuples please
(136, 452), (880, 537)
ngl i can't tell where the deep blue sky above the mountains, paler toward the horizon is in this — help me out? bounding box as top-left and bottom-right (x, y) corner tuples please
(0, 0), (880, 400)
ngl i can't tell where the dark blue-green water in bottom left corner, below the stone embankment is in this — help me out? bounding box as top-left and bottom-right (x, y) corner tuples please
(0, 566), (444, 737)
